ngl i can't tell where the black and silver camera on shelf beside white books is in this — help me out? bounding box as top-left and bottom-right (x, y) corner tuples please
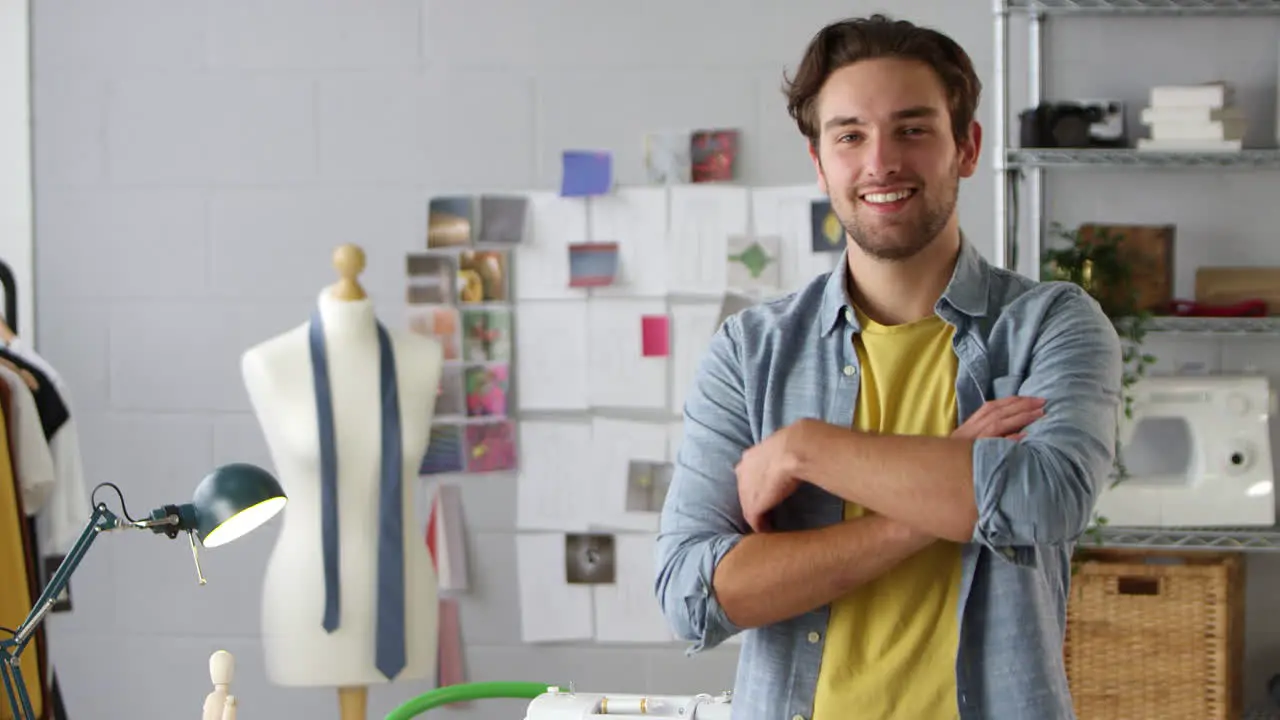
(1018, 100), (1129, 147)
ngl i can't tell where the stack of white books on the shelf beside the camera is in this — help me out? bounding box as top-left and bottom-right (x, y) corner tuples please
(1138, 81), (1247, 152)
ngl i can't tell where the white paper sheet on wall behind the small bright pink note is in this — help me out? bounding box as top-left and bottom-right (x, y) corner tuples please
(586, 297), (671, 410)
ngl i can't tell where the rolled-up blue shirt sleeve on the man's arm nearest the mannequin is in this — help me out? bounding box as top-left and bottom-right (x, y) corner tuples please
(654, 318), (751, 655)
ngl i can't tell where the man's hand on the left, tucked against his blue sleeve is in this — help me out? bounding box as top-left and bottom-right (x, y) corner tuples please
(733, 420), (813, 533)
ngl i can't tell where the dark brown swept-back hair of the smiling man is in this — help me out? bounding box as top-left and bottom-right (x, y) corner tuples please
(783, 14), (982, 147)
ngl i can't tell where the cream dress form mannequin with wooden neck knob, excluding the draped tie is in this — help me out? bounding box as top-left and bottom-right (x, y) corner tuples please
(241, 245), (443, 720)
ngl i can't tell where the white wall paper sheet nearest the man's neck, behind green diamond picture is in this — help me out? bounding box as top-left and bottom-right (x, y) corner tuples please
(751, 184), (840, 292)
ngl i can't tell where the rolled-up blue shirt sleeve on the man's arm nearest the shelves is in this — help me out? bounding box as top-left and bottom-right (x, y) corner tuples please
(973, 285), (1124, 556)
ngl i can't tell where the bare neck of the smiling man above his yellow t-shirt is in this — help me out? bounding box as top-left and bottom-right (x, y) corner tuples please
(847, 225), (960, 325)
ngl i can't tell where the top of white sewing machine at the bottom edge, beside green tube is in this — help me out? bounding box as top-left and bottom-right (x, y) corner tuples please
(525, 688), (733, 720)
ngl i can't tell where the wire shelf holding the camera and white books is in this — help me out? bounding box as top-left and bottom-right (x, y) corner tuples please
(1006, 147), (1280, 170)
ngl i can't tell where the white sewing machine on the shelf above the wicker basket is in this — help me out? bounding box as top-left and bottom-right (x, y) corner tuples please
(1097, 375), (1276, 528)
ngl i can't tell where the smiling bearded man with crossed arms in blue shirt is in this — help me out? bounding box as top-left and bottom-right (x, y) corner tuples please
(655, 15), (1121, 720)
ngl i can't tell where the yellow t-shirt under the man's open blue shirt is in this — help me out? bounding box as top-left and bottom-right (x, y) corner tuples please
(813, 304), (960, 720)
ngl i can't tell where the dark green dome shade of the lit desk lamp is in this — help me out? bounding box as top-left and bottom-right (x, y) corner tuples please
(191, 462), (287, 547)
